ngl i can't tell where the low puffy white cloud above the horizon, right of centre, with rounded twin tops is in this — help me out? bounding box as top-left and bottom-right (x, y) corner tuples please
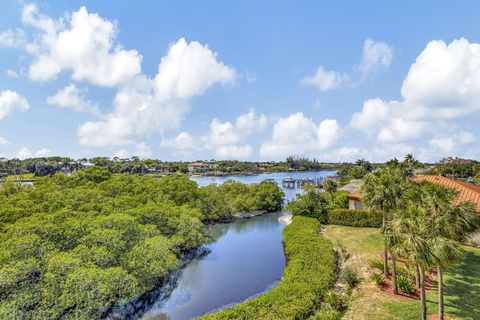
(260, 112), (341, 159)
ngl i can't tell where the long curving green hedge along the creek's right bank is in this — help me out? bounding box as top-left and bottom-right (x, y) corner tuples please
(198, 216), (336, 320)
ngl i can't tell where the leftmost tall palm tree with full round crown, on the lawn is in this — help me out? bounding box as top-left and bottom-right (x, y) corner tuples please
(361, 166), (410, 281)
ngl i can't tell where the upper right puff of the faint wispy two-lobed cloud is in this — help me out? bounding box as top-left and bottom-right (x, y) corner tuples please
(357, 38), (393, 77)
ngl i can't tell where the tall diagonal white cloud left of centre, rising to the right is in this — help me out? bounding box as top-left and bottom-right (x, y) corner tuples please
(78, 38), (235, 146)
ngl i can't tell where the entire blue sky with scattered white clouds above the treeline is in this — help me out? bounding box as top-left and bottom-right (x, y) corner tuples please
(0, 0), (480, 161)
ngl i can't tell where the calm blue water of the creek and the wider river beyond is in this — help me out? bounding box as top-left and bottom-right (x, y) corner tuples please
(142, 171), (334, 320)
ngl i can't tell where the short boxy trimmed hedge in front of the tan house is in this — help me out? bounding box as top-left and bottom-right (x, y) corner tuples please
(327, 209), (382, 228)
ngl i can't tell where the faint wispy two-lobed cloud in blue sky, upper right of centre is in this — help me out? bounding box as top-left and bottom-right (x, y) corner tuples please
(301, 38), (393, 91)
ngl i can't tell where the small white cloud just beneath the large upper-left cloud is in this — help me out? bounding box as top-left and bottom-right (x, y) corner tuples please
(47, 84), (100, 115)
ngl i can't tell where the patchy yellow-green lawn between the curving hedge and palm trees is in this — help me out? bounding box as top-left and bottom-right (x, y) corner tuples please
(324, 225), (480, 320)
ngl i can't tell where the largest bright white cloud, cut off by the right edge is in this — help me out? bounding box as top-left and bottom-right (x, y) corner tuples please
(350, 38), (480, 143)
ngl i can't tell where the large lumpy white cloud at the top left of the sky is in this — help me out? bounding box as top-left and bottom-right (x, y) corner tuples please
(22, 4), (142, 86)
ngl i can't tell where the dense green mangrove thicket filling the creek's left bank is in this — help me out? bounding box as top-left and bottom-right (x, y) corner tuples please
(0, 171), (283, 319)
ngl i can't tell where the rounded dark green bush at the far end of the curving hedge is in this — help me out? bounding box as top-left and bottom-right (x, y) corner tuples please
(285, 189), (328, 223)
